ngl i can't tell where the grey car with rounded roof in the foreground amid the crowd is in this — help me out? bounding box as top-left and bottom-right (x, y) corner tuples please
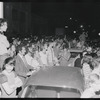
(21, 66), (84, 98)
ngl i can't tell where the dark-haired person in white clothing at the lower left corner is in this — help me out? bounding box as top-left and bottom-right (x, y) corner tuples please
(0, 57), (23, 98)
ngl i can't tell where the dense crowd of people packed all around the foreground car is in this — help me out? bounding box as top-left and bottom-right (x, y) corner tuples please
(0, 19), (100, 98)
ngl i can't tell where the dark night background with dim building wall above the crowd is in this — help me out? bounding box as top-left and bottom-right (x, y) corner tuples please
(4, 0), (100, 39)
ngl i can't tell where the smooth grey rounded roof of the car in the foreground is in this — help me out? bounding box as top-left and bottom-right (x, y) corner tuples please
(25, 66), (84, 92)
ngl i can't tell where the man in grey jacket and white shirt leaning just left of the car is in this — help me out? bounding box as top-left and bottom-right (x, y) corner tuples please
(15, 44), (34, 97)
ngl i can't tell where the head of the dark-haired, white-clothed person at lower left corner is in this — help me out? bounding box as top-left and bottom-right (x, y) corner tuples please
(2, 57), (15, 73)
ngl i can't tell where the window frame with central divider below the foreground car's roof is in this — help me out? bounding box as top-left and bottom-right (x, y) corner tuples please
(25, 85), (82, 98)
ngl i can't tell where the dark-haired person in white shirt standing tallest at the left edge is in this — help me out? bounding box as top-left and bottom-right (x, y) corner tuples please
(0, 18), (10, 71)
